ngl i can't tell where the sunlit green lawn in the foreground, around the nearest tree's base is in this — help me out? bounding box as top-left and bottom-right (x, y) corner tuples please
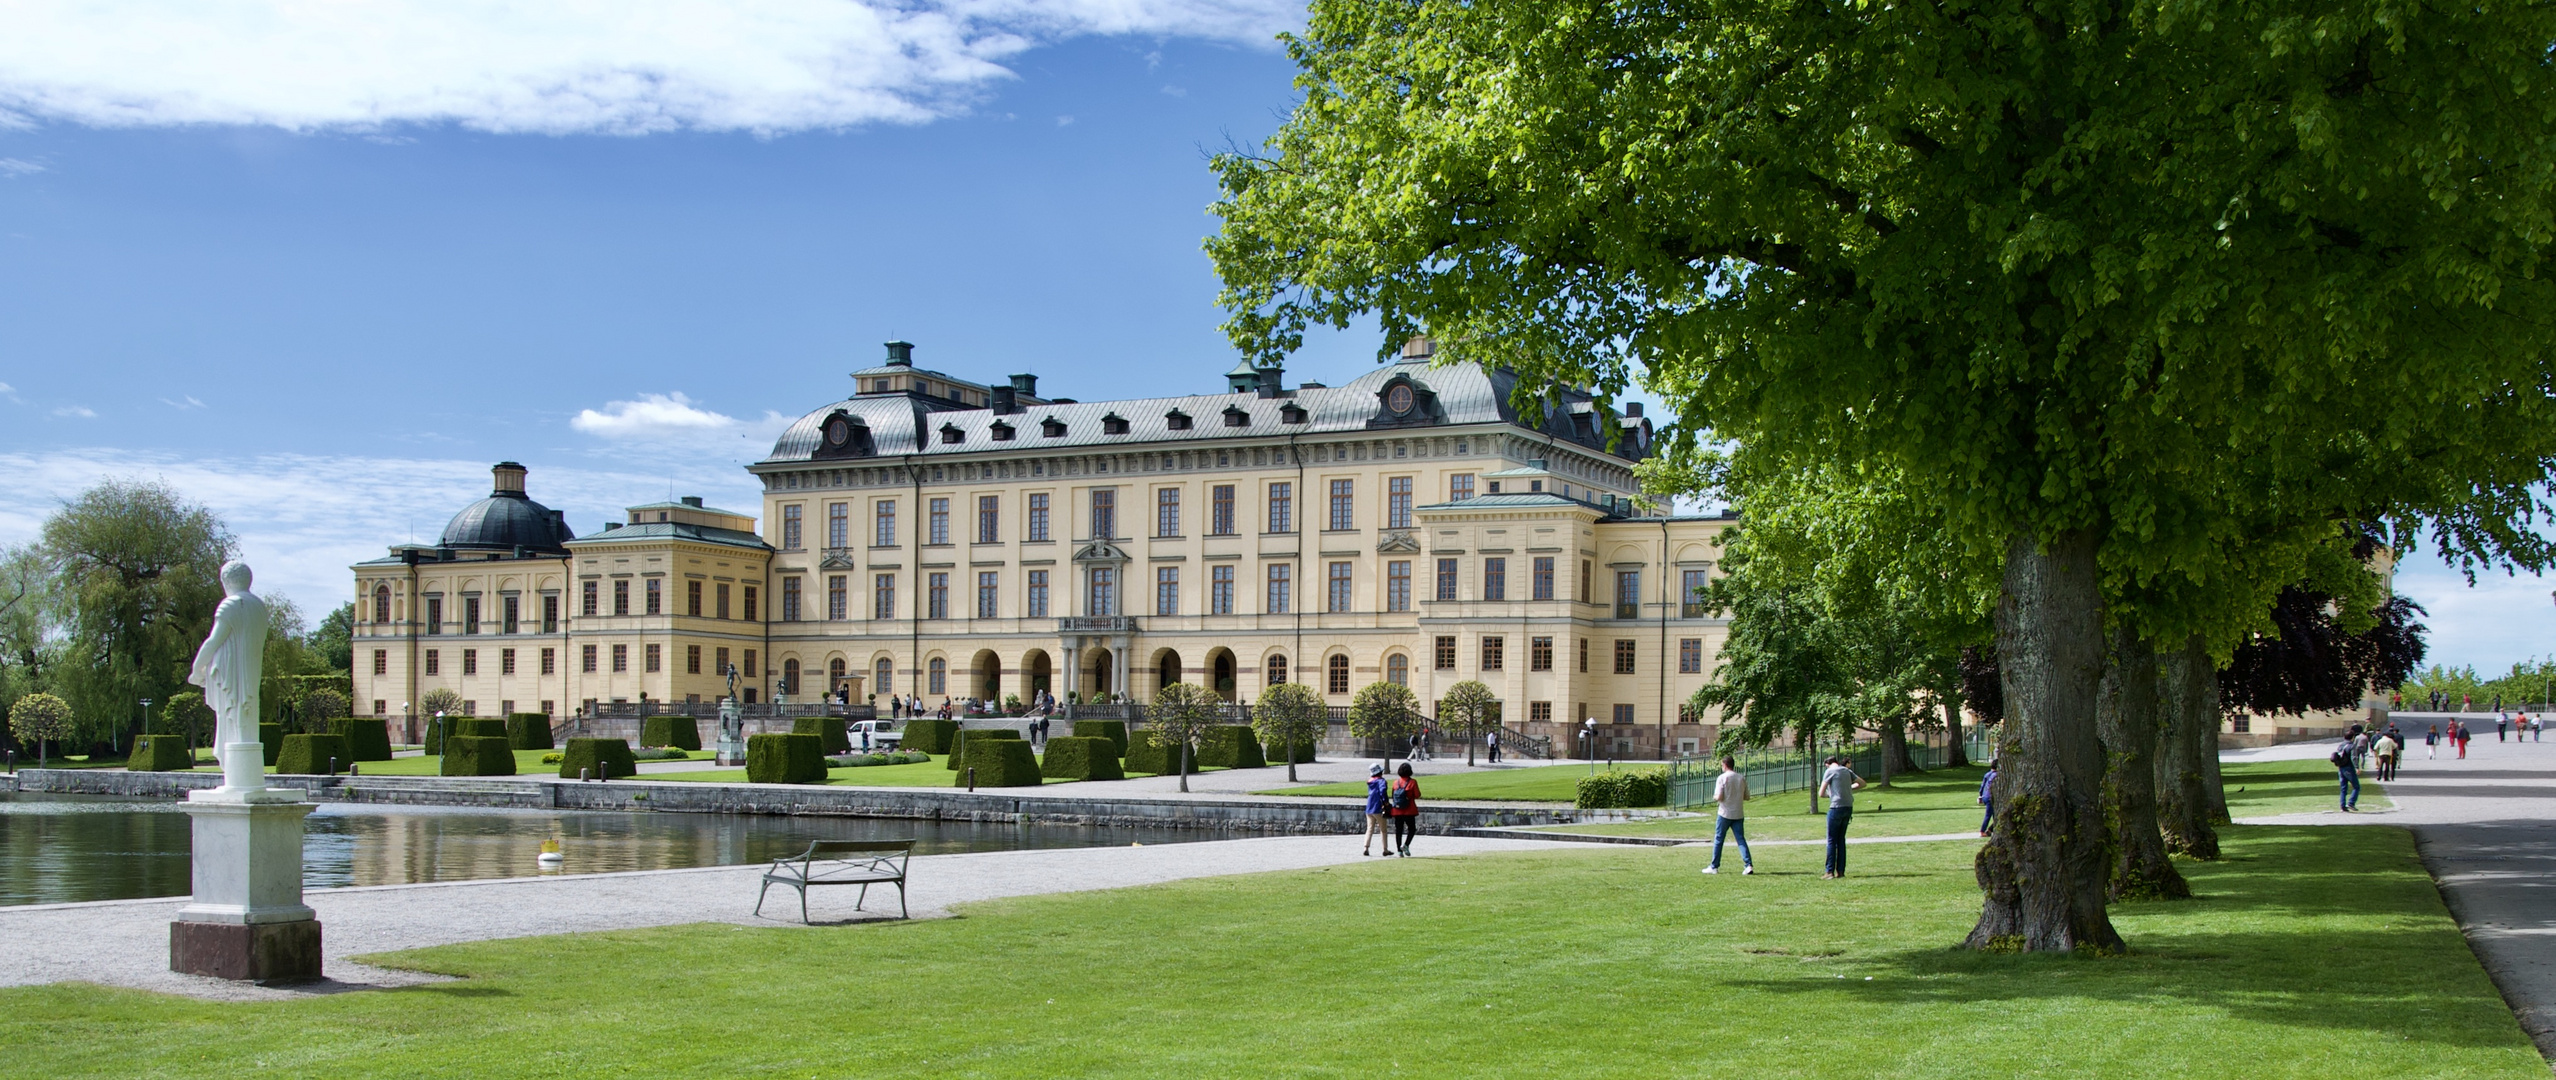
(0, 827), (2546, 1080)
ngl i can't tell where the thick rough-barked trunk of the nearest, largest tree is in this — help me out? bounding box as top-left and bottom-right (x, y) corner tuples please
(1963, 531), (2124, 955)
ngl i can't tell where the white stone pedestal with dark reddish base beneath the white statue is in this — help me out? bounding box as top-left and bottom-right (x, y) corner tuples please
(169, 786), (320, 983)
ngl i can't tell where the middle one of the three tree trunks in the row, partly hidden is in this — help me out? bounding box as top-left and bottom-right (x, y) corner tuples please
(2098, 628), (2193, 901)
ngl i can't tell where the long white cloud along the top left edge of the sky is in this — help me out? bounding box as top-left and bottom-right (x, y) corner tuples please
(0, 0), (1304, 133)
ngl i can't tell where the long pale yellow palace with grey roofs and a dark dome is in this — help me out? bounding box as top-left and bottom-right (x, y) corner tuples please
(355, 340), (1733, 756)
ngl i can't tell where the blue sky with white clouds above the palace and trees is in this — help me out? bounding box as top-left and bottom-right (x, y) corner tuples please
(0, 0), (2556, 669)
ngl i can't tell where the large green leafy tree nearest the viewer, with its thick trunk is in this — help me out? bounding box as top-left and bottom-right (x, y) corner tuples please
(1209, 0), (2556, 952)
